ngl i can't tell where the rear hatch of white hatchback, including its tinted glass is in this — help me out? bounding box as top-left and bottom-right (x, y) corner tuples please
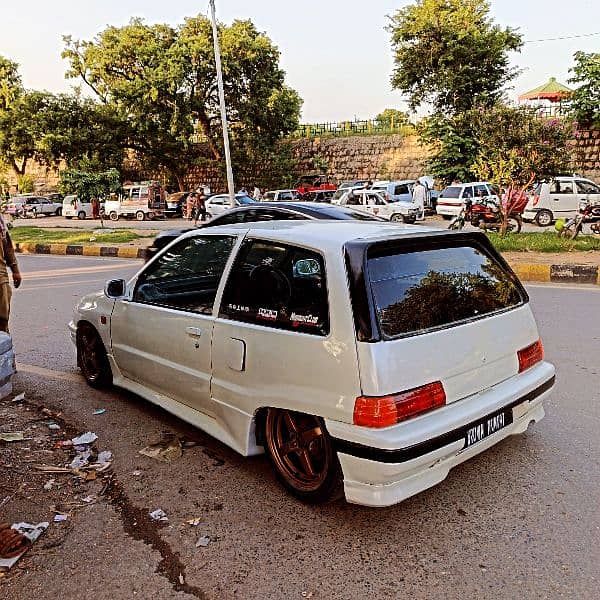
(346, 233), (538, 403)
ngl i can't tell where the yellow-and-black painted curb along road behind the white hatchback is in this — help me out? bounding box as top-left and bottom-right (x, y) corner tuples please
(15, 243), (600, 285)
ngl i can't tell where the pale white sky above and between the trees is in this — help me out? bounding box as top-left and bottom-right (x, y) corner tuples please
(0, 0), (600, 122)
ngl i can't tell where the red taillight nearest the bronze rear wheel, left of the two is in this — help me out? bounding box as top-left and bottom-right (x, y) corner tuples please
(354, 381), (446, 427)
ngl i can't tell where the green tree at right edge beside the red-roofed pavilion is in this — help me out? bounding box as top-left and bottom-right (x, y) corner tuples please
(569, 52), (600, 127)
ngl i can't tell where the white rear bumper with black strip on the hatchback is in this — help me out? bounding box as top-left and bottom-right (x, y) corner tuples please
(326, 362), (554, 506)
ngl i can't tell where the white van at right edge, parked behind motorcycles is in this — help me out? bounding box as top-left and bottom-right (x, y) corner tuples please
(523, 176), (600, 227)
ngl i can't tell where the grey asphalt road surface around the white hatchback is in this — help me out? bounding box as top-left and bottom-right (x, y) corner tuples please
(0, 256), (600, 600)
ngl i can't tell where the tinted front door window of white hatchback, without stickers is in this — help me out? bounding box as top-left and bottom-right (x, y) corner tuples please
(132, 236), (235, 315)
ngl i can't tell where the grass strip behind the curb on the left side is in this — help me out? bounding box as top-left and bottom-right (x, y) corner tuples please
(10, 227), (156, 244)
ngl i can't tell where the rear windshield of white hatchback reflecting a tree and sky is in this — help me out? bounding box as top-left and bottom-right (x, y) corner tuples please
(368, 245), (525, 339)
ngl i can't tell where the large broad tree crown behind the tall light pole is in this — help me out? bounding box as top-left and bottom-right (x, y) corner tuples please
(63, 16), (301, 189)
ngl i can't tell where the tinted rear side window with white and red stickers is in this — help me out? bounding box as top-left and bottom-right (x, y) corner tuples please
(219, 240), (329, 336)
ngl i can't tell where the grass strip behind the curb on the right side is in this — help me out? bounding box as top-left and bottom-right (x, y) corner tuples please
(488, 231), (600, 252)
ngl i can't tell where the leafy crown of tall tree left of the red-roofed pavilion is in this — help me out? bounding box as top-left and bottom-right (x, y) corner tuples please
(388, 0), (523, 113)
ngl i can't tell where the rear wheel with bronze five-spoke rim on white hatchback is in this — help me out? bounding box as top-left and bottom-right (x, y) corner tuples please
(263, 408), (342, 504)
